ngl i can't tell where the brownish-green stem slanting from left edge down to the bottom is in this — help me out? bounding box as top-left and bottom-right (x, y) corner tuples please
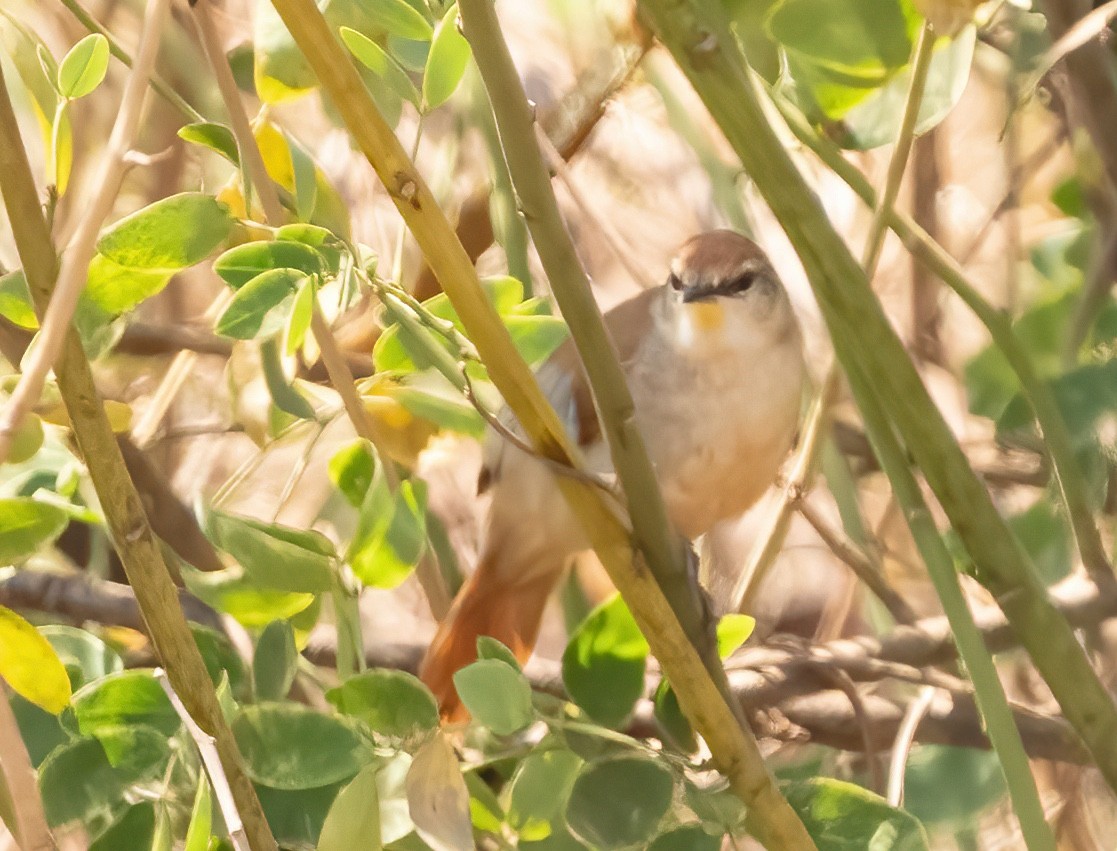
(0, 59), (276, 851)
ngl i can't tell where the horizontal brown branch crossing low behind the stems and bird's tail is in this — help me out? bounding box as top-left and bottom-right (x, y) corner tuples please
(0, 572), (1099, 763)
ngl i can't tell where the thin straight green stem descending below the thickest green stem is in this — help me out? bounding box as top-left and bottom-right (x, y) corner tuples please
(850, 361), (1056, 851)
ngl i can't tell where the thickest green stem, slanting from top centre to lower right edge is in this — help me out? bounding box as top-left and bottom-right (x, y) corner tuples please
(640, 0), (1117, 788)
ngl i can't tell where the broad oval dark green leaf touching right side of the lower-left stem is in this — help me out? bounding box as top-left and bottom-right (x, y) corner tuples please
(232, 704), (374, 791)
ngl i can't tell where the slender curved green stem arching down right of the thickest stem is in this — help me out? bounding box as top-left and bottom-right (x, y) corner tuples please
(774, 87), (1114, 586)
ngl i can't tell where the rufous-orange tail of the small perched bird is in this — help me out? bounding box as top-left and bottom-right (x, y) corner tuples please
(419, 553), (556, 721)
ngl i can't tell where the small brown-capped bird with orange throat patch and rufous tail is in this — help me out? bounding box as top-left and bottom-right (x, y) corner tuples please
(419, 230), (805, 721)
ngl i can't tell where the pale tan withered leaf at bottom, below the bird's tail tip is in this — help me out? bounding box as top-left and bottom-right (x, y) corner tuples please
(407, 733), (474, 849)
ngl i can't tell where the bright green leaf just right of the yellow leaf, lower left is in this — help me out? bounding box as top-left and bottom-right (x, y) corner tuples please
(73, 669), (180, 736)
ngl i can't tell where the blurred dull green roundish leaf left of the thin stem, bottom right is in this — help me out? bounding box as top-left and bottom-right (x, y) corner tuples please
(904, 745), (1008, 828)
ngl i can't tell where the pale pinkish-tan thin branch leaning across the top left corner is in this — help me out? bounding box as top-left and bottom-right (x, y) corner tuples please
(0, 0), (171, 463)
